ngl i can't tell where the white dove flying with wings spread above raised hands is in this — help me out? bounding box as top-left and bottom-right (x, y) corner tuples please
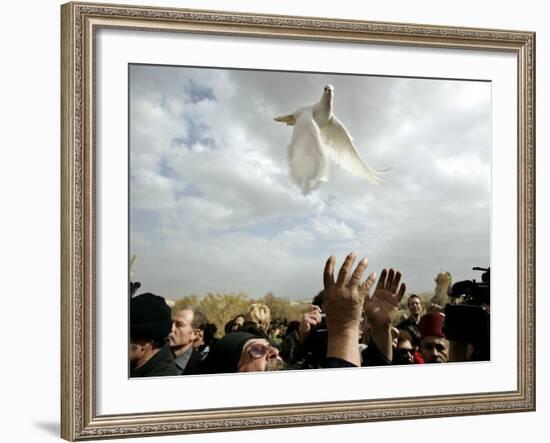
(275, 85), (385, 194)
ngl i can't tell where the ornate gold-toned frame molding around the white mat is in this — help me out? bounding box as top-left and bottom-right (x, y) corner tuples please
(61, 2), (535, 441)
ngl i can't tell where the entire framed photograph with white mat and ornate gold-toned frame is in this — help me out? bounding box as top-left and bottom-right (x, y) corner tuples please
(61, 2), (535, 441)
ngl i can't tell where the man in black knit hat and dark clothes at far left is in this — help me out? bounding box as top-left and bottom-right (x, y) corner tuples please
(130, 293), (178, 377)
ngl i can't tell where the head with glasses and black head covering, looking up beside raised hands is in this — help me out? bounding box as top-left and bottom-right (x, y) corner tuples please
(203, 331), (282, 374)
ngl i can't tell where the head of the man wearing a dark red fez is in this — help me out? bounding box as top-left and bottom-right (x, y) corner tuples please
(419, 313), (449, 363)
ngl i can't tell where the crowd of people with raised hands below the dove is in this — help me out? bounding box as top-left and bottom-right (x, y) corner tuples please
(129, 253), (488, 377)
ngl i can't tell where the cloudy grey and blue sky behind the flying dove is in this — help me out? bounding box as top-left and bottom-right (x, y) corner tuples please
(130, 65), (491, 299)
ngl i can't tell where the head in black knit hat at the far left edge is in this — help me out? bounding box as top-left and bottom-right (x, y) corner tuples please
(129, 293), (172, 365)
